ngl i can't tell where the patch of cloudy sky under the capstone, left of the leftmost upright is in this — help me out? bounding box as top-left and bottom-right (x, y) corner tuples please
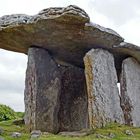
(0, 49), (27, 111)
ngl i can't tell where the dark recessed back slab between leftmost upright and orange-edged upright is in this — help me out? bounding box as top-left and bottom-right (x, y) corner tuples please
(59, 66), (88, 131)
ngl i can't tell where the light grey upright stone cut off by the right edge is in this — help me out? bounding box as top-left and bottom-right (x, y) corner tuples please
(120, 58), (140, 127)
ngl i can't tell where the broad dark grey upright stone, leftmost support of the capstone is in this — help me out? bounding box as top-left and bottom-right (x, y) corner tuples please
(25, 48), (61, 133)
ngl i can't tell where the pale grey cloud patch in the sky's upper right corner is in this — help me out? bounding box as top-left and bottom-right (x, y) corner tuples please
(91, 0), (140, 25)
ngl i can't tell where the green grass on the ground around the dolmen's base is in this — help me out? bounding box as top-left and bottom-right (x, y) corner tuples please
(0, 121), (140, 140)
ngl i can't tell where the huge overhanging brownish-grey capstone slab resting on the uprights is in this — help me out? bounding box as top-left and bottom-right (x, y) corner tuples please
(0, 5), (123, 67)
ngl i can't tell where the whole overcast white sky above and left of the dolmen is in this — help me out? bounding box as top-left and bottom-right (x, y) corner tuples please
(0, 0), (140, 111)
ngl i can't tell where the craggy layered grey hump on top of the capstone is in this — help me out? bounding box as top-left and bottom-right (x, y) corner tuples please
(30, 5), (90, 24)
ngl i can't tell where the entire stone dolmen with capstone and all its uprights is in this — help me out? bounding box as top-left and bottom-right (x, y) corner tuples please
(0, 5), (140, 133)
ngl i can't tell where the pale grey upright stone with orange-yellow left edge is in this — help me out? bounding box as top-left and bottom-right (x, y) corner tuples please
(84, 49), (123, 128)
